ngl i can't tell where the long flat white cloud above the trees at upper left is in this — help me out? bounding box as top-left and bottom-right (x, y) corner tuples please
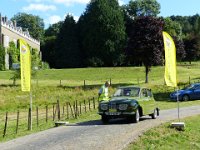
(22, 4), (56, 12)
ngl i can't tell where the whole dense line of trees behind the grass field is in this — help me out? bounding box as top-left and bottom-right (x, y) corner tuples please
(7, 0), (200, 69)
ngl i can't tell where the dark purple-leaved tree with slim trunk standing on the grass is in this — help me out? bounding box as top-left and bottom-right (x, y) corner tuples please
(127, 16), (163, 83)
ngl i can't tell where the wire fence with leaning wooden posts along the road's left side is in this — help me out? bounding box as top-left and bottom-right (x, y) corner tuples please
(0, 97), (98, 138)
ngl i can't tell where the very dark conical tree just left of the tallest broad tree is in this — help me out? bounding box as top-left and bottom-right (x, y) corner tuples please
(54, 15), (82, 68)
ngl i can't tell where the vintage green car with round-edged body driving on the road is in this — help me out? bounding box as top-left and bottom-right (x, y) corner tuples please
(98, 86), (159, 123)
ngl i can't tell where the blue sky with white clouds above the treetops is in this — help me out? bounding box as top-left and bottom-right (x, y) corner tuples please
(0, 0), (200, 28)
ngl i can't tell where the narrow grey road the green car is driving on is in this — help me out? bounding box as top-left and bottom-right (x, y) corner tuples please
(0, 106), (200, 150)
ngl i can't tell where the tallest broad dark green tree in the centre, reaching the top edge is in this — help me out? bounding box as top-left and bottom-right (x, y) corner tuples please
(79, 0), (126, 66)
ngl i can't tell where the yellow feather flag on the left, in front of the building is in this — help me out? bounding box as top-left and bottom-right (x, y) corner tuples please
(19, 39), (31, 92)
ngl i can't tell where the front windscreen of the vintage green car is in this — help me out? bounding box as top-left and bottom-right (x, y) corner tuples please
(113, 88), (140, 97)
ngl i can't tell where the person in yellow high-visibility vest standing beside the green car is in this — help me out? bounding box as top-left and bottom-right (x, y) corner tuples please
(98, 81), (110, 101)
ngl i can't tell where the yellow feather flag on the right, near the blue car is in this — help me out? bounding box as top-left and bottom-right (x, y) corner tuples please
(163, 31), (177, 87)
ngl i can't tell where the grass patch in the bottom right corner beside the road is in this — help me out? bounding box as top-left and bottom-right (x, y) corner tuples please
(126, 115), (200, 150)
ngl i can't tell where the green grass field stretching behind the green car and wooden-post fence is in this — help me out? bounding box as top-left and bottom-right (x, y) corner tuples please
(0, 62), (200, 141)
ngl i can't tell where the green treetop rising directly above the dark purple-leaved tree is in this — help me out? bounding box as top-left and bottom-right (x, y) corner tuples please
(127, 0), (160, 17)
